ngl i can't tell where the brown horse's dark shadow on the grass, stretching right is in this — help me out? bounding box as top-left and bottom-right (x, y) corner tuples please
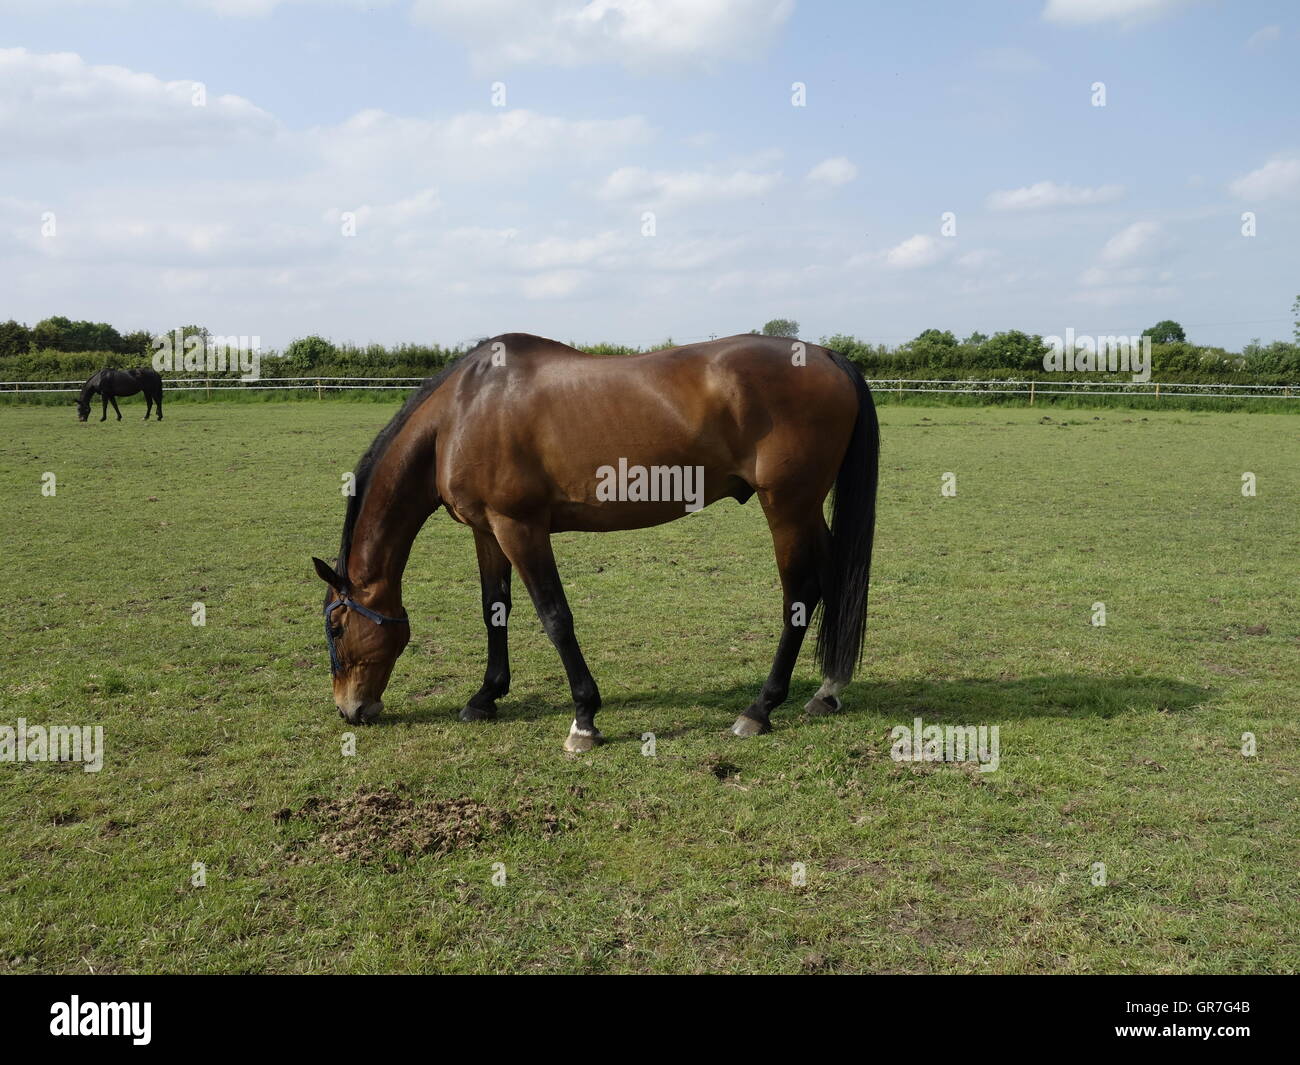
(378, 674), (1214, 728)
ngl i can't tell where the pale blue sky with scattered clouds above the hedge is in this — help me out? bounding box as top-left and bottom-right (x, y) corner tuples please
(0, 0), (1300, 350)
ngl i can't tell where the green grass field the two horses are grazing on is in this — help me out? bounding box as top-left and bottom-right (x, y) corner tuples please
(0, 401), (1300, 973)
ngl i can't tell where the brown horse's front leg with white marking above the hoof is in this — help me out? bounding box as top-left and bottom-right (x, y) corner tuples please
(491, 515), (605, 753)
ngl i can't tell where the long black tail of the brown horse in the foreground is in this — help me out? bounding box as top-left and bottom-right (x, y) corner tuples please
(816, 351), (880, 684)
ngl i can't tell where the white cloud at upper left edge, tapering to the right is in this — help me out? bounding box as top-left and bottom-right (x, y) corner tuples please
(0, 48), (278, 160)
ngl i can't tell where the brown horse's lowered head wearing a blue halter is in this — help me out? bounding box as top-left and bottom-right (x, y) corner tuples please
(312, 558), (411, 724)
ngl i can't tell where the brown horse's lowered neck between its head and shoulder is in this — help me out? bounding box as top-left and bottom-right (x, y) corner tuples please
(347, 433), (438, 611)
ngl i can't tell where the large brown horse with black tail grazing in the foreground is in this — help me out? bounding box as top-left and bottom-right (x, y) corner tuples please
(312, 333), (879, 752)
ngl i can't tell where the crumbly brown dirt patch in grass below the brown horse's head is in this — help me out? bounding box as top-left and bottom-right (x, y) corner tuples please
(274, 788), (571, 867)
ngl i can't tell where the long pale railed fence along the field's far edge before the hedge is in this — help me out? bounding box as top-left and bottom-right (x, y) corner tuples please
(0, 377), (1300, 403)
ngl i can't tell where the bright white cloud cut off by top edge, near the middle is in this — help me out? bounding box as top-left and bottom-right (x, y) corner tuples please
(411, 0), (794, 70)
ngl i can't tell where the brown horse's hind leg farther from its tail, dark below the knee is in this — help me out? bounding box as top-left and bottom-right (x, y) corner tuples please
(732, 498), (831, 736)
